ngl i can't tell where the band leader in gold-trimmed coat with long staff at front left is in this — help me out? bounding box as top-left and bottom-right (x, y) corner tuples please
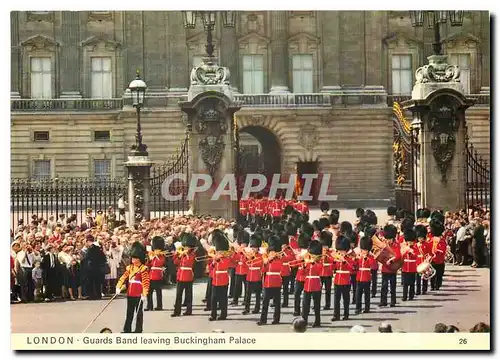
(116, 242), (149, 333)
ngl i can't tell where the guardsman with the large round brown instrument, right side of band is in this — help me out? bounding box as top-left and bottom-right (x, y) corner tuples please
(379, 225), (401, 307)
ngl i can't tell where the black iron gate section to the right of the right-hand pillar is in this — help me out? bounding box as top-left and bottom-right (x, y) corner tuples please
(465, 142), (491, 209)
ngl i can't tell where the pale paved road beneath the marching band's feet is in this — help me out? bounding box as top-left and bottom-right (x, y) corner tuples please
(11, 266), (490, 333)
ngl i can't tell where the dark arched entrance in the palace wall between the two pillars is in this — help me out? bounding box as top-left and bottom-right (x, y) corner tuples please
(238, 126), (281, 195)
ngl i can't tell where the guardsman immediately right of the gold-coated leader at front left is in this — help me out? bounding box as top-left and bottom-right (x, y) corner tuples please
(144, 236), (166, 311)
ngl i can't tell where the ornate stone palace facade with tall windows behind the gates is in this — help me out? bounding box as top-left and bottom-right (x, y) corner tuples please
(11, 11), (490, 206)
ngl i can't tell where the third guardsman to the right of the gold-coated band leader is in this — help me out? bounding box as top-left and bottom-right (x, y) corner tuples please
(208, 229), (233, 321)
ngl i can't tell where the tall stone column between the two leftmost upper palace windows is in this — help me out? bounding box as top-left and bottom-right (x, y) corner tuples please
(60, 11), (82, 99)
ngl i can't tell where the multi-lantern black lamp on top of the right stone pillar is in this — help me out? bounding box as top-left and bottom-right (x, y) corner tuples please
(410, 10), (464, 55)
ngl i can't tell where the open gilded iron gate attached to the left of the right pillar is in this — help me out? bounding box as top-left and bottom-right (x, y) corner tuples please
(392, 102), (420, 212)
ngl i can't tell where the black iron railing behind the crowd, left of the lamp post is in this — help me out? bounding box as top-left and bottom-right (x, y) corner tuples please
(10, 178), (127, 229)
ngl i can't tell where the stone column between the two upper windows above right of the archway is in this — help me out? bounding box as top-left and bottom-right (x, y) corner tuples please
(270, 11), (289, 93)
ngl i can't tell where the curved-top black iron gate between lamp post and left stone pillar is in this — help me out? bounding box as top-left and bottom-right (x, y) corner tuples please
(149, 133), (189, 218)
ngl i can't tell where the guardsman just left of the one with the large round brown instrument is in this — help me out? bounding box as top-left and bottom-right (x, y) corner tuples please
(355, 235), (373, 314)
